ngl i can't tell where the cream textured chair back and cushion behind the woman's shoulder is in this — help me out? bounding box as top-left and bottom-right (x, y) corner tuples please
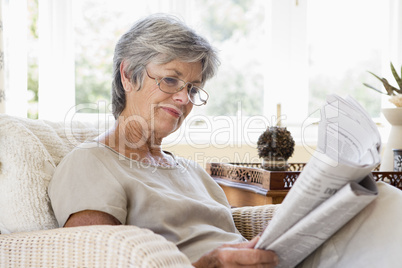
(0, 114), (103, 234)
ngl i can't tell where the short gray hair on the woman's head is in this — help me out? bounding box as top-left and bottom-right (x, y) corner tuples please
(112, 14), (219, 119)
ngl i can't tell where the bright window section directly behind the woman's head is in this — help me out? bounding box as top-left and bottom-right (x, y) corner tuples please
(74, 0), (265, 118)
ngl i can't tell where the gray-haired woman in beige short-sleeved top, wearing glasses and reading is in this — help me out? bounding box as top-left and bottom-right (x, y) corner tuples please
(49, 15), (277, 267)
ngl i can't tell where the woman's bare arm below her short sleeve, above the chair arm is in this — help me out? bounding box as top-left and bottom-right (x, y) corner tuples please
(64, 210), (121, 227)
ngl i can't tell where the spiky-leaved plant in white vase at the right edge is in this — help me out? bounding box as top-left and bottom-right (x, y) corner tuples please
(363, 62), (402, 171)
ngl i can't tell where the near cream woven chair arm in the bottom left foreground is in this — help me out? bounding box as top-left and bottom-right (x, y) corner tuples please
(0, 225), (192, 268)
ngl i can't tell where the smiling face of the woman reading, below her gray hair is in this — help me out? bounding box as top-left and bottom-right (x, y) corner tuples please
(118, 60), (202, 139)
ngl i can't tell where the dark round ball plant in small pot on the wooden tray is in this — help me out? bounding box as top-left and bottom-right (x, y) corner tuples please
(257, 126), (295, 171)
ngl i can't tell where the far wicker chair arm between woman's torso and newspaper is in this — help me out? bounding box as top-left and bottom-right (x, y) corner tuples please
(232, 205), (279, 240)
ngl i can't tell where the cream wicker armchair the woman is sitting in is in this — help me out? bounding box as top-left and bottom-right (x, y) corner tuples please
(0, 115), (277, 268)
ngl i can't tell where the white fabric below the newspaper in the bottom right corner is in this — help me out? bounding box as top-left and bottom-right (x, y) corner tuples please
(298, 182), (402, 268)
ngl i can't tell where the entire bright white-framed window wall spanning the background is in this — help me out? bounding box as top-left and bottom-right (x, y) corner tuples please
(3, 0), (402, 146)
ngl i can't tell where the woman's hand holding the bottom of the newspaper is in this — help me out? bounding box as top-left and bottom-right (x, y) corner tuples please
(193, 237), (279, 268)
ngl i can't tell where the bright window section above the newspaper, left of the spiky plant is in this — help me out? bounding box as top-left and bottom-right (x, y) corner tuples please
(307, 0), (389, 117)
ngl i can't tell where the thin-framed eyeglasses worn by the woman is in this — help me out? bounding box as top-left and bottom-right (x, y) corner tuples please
(145, 69), (209, 106)
